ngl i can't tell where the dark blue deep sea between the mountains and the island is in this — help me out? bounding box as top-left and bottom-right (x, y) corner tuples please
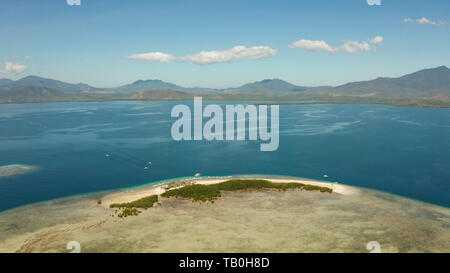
(0, 101), (450, 210)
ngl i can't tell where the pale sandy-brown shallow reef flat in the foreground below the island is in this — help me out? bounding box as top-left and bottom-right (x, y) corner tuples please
(0, 180), (450, 252)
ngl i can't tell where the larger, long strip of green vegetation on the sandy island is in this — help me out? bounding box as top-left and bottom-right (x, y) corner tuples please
(161, 179), (333, 202)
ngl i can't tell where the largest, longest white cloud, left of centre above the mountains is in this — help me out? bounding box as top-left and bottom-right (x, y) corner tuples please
(126, 45), (277, 65)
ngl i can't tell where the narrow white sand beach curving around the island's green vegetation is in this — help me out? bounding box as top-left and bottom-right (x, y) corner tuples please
(101, 175), (359, 208)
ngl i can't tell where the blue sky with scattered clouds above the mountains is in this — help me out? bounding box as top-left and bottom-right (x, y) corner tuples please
(0, 0), (450, 88)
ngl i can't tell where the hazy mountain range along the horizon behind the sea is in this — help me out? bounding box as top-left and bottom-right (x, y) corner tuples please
(0, 66), (450, 102)
